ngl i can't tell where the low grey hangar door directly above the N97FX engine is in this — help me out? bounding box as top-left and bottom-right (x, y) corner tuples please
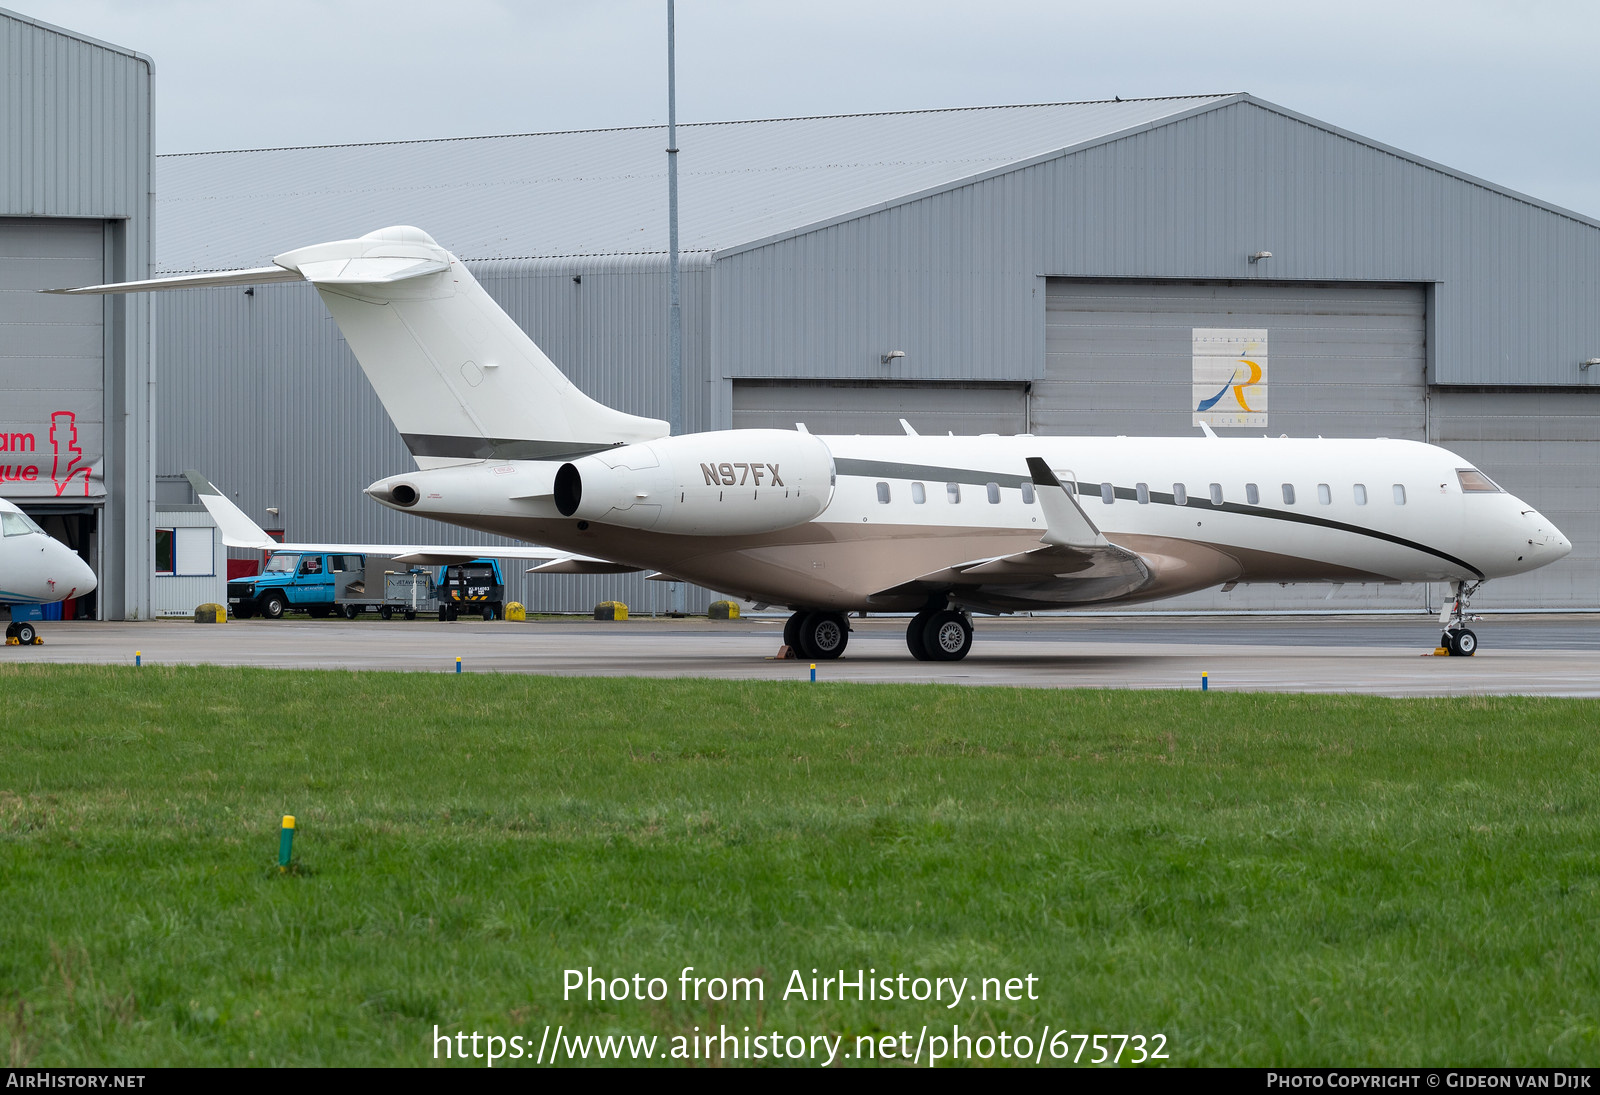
(733, 379), (1027, 435)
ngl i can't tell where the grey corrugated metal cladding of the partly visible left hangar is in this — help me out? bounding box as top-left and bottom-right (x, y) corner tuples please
(0, 11), (155, 618)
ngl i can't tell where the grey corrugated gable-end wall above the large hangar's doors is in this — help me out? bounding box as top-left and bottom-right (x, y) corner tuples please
(712, 101), (1600, 387)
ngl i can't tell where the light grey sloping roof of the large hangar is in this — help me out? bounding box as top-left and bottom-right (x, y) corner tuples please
(155, 94), (1240, 272)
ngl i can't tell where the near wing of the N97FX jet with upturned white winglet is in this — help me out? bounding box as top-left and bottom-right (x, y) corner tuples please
(883, 456), (1154, 604)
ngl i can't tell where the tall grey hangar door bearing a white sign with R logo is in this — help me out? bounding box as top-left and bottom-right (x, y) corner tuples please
(1029, 279), (1437, 612)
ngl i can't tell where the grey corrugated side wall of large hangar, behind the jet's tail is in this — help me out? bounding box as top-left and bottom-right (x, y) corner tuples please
(155, 256), (714, 613)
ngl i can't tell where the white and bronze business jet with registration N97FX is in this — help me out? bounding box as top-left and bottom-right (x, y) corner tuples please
(58, 227), (1571, 661)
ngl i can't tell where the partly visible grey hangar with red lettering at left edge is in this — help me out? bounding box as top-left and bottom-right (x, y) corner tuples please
(0, 10), (155, 620)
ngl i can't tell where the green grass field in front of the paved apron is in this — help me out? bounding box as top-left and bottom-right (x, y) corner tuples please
(0, 666), (1600, 1065)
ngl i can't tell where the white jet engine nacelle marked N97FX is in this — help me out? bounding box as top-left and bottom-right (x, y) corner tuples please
(555, 429), (834, 536)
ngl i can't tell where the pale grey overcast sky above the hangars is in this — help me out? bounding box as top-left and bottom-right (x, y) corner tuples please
(5, 0), (1600, 218)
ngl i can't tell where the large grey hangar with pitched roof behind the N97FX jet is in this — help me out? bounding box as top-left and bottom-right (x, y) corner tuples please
(155, 94), (1600, 612)
